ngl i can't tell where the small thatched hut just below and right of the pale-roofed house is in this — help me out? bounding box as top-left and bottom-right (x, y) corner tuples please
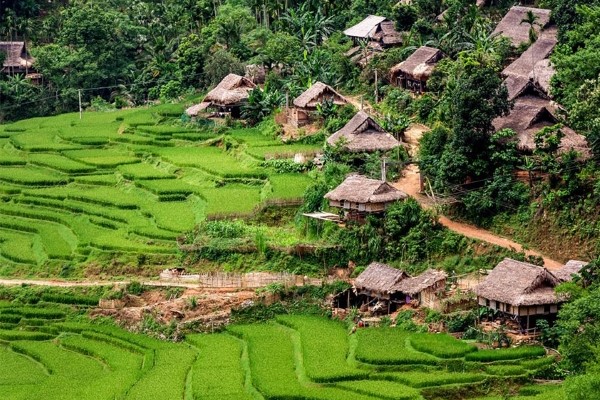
(390, 46), (442, 93)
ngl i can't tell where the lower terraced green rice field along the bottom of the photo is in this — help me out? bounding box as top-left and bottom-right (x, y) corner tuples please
(0, 310), (565, 400)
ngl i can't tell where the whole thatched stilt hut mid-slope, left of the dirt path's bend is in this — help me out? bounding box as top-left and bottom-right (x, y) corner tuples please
(325, 175), (408, 220)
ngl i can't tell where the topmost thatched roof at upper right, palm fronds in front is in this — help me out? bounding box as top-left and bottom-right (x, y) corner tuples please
(493, 6), (550, 47)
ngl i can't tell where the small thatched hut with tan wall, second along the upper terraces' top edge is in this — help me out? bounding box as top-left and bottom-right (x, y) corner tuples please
(289, 82), (348, 128)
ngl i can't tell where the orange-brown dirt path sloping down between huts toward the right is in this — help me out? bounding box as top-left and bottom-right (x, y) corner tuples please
(394, 164), (563, 269)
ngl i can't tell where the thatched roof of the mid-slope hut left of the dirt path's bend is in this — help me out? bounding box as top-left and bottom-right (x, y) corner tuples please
(325, 175), (407, 204)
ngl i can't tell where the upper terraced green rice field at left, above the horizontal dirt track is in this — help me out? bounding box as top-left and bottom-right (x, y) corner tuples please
(0, 104), (320, 268)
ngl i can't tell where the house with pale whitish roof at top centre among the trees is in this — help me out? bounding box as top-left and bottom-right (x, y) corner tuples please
(344, 15), (402, 67)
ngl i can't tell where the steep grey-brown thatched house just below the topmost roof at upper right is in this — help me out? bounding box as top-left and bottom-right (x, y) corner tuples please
(502, 27), (558, 100)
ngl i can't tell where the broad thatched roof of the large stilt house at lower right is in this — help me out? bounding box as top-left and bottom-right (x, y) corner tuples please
(475, 258), (563, 306)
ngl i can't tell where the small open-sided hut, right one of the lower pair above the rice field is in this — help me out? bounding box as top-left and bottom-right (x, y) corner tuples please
(398, 268), (448, 311)
